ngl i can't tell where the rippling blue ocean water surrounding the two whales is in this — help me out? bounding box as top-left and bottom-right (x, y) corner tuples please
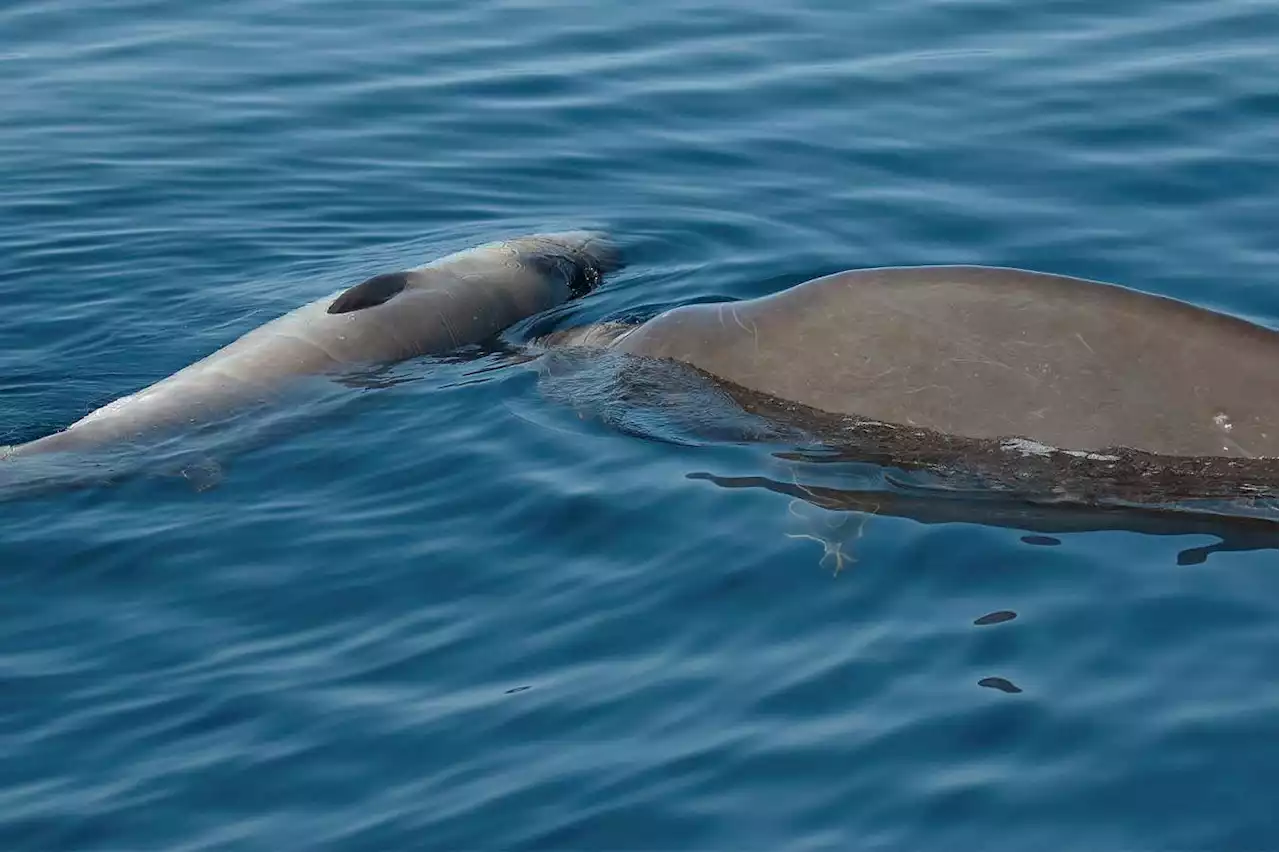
(0, 0), (1280, 852)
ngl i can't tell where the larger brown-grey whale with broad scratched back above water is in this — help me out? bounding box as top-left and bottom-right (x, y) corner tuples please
(541, 266), (1280, 459)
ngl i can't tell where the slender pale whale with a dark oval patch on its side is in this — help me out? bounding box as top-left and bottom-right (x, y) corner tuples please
(0, 230), (621, 459)
